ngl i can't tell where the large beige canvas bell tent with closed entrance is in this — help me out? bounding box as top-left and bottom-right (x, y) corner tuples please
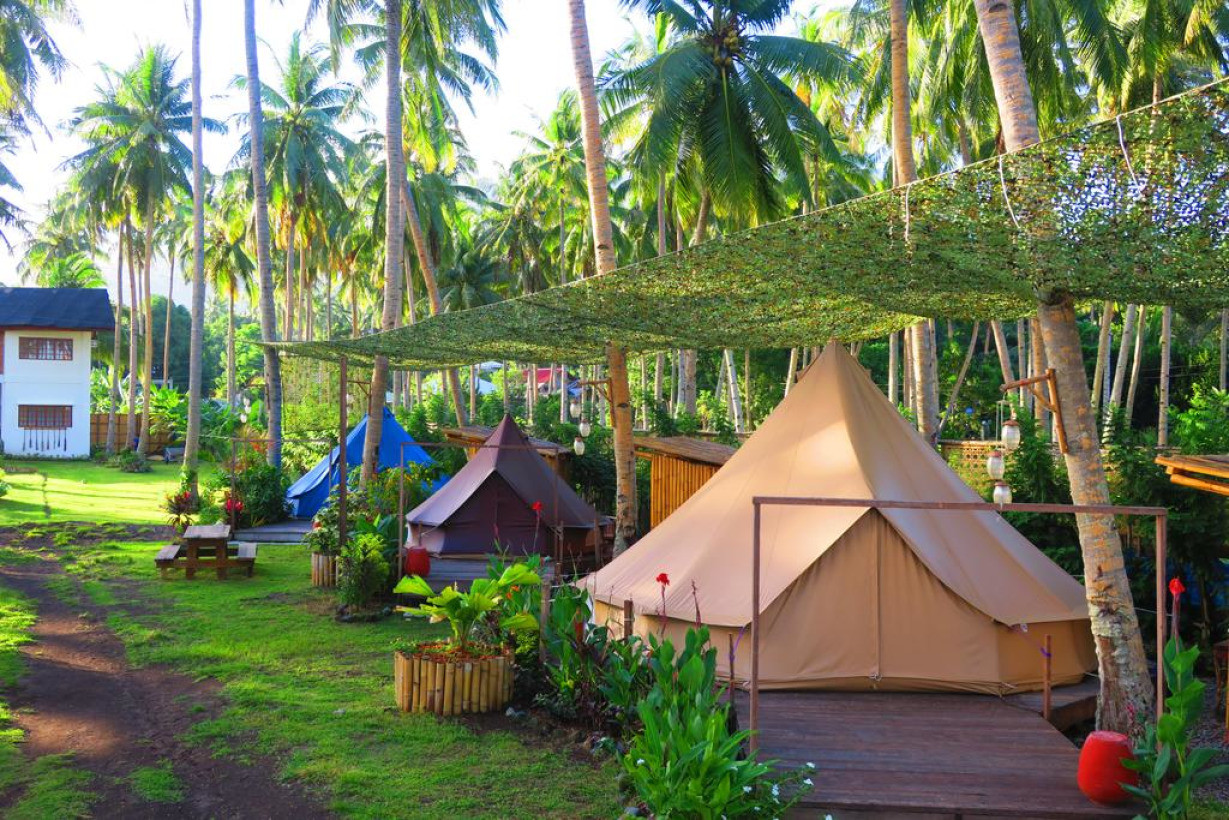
(584, 344), (1096, 693)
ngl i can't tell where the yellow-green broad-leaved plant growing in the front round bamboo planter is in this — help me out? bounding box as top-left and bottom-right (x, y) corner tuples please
(392, 563), (542, 654)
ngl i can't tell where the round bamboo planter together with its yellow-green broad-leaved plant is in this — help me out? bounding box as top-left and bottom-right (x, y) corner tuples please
(393, 563), (541, 716)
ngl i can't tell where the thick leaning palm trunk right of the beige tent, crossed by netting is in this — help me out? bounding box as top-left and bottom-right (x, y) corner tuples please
(973, 0), (1153, 734)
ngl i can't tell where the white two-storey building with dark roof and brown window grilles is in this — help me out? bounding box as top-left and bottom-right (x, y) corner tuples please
(0, 288), (114, 459)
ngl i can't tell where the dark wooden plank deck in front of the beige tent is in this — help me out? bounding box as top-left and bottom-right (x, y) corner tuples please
(737, 692), (1133, 820)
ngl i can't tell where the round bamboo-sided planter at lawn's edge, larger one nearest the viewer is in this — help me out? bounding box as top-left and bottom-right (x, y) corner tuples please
(392, 649), (512, 716)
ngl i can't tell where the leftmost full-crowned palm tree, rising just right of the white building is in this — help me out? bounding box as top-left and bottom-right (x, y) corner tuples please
(70, 47), (207, 455)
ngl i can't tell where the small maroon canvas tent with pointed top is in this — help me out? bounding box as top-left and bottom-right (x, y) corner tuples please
(406, 416), (597, 557)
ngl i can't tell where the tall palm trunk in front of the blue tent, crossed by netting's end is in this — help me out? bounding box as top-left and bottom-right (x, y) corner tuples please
(359, 0), (406, 487)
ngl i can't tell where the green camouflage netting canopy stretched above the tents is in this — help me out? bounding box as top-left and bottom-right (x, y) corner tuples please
(283, 81), (1229, 369)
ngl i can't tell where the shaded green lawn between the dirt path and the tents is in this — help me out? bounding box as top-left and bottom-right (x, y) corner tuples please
(52, 543), (619, 818)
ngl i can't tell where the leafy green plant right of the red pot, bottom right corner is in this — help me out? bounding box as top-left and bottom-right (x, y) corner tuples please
(1123, 637), (1229, 820)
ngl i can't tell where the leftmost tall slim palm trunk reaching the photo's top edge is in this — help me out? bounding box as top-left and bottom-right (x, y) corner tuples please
(183, 0), (205, 486)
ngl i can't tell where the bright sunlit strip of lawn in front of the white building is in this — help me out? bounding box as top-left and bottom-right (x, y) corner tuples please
(0, 461), (179, 526)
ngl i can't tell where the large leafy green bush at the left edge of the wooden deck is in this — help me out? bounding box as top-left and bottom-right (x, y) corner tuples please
(622, 627), (814, 820)
